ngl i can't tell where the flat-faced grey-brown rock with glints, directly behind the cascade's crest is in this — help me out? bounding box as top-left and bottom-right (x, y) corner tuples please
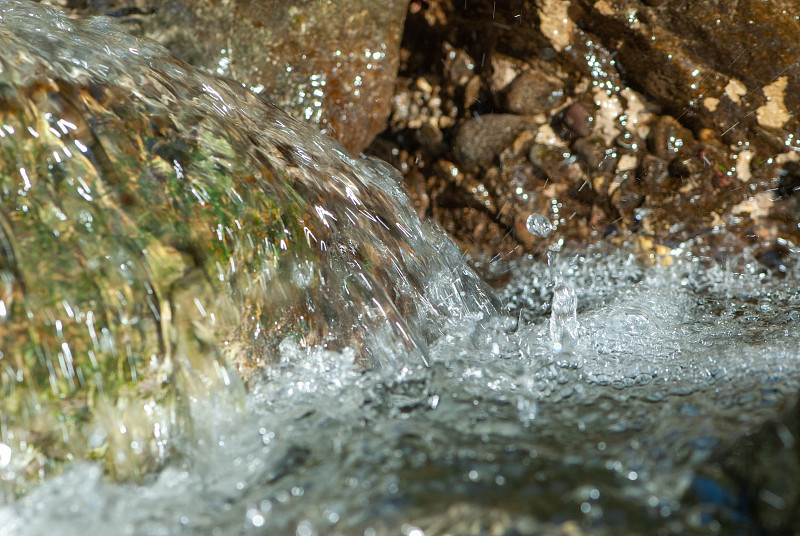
(40, 0), (408, 152)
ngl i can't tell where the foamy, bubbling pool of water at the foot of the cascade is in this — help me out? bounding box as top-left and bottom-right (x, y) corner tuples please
(6, 244), (800, 534)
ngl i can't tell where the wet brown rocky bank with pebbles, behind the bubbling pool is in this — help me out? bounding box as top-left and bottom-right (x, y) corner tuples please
(370, 0), (800, 272)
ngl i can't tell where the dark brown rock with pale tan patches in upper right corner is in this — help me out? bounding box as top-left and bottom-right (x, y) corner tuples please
(574, 0), (800, 150)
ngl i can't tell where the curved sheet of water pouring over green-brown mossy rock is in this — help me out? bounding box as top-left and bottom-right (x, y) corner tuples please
(0, 0), (493, 492)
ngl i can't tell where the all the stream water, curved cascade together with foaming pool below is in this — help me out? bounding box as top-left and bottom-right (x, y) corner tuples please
(0, 1), (800, 536)
